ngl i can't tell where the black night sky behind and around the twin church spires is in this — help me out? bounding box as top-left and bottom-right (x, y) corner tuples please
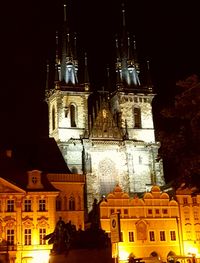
(0, 0), (200, 144)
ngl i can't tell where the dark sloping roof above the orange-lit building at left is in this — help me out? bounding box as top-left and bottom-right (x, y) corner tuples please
(0, 138), (71, 191)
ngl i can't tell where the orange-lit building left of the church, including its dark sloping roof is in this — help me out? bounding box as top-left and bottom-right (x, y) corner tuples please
(0, 144), (85, 263)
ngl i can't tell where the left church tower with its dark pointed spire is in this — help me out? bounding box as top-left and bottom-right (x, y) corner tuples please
(46, 4), (90, 173)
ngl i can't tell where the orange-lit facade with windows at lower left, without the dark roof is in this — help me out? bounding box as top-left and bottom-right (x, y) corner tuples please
(0, 170), (85, 263)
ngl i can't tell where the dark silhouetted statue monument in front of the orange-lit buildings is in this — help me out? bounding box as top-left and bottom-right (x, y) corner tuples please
(45, 200), (113, 263)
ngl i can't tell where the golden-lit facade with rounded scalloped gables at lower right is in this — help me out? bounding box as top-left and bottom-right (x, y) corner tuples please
(100, 186), (200, 262)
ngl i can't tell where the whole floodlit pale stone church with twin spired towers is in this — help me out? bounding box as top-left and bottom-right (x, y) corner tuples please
(46, 4), (165, 209)
